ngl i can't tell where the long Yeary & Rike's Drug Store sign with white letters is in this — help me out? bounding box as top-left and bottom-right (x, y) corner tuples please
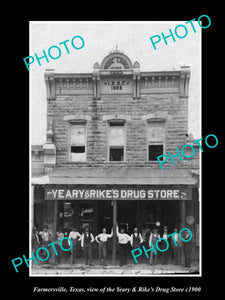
(45, 186), (191, 200)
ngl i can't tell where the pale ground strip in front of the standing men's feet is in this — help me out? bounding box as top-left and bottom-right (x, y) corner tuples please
(31, 263), (199, 276)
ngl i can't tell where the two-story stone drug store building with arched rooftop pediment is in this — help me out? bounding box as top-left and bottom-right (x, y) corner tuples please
(32, 50), (199, 263)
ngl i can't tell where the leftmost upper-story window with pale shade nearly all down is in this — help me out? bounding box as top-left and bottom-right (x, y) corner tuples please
(69, 122), (87, 162)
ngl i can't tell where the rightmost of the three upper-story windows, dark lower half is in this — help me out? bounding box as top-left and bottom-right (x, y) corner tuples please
(147, 119), (165, 161)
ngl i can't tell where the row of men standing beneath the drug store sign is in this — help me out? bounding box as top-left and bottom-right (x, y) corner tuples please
(32, 224), (191, 267)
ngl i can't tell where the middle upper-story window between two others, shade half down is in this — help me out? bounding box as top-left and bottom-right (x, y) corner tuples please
(108, 121), (125, 161)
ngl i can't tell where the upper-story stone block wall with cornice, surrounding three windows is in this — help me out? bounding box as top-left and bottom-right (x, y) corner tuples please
(45, 50), (193, 168)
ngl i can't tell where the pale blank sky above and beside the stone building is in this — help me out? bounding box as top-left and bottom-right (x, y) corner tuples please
(29, 20), (201, 145)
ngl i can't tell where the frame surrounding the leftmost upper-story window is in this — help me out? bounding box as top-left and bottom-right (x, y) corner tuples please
(67, 120), (87, 163)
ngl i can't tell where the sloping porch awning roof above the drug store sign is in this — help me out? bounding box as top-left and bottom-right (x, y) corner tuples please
(31, 167), (198, 185)
